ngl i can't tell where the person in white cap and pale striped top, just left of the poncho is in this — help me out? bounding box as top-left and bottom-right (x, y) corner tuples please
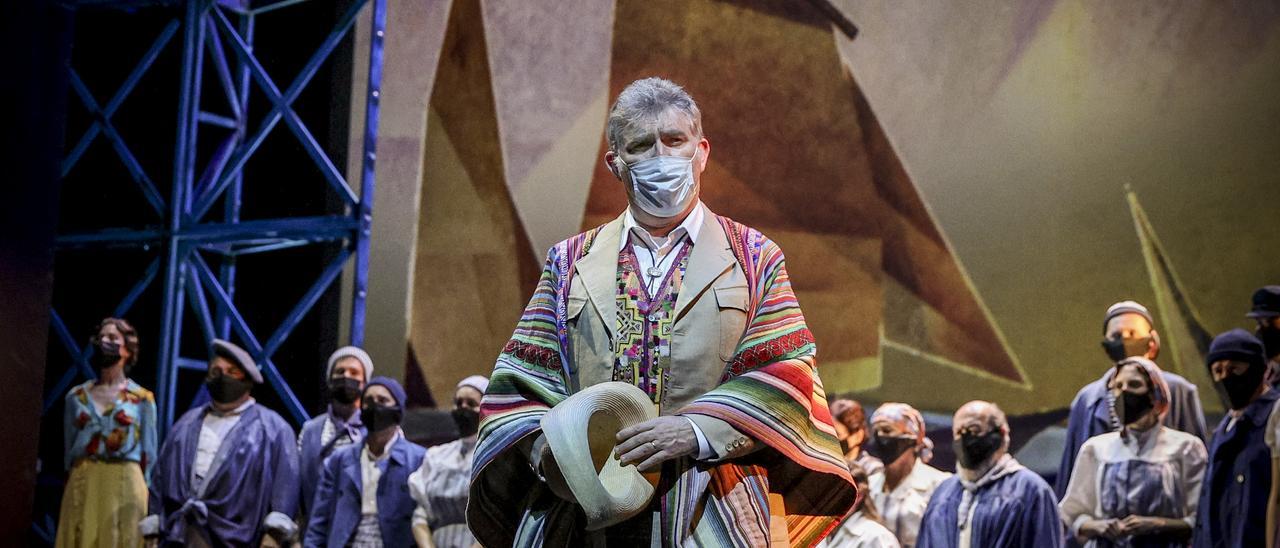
(408, 375), (489, 548)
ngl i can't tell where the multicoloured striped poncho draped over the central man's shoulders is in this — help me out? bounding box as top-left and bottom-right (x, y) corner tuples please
(467, 216), (858, 547)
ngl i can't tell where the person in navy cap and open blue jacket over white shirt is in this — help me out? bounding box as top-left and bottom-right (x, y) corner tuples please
(305, 376), (426, 548)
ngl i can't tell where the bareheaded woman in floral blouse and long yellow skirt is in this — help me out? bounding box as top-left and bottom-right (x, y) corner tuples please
(56, 318), (157, 547)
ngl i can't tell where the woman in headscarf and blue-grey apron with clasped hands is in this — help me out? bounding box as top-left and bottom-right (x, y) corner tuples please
(1059, 357), (1207, 548)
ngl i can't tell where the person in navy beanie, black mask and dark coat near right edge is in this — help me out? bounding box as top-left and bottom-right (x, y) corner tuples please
(1193, 329), (1280, 548)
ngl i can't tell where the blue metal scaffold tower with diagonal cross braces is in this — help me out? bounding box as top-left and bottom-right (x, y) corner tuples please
(45, 0), (387, 435)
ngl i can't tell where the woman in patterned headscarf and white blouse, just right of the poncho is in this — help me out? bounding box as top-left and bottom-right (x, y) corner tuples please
(867, 402), (951, 548)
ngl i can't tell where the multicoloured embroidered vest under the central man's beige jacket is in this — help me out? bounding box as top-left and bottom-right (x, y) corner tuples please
(613, 243), (692, 403)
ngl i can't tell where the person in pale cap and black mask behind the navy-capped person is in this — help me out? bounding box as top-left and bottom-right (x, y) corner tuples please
(298, 346), (374, 528)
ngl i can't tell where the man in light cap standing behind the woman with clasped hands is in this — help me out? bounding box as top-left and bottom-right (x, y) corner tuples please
(1053, 301), (1208, 501)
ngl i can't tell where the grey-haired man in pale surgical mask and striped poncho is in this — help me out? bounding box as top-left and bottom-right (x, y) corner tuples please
(467, 78), (856, 545)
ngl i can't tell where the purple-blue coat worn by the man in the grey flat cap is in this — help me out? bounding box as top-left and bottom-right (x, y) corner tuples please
(150, 403), (298, 547)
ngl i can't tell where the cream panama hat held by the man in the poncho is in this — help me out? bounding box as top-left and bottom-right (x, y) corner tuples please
(543, 382), (658, 531)
